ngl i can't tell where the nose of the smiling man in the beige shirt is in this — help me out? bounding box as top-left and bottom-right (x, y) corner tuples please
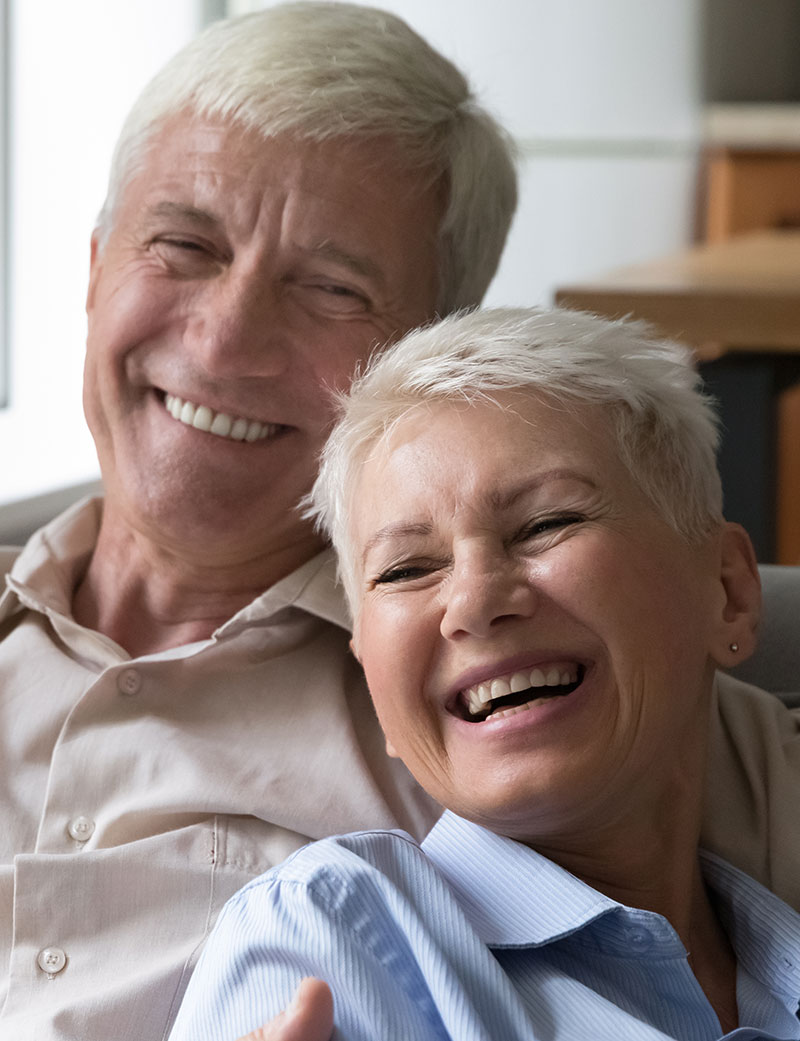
(185, 271), (292, 378)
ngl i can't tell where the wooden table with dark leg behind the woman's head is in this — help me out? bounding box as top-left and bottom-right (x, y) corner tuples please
(555, 230), (800, 564)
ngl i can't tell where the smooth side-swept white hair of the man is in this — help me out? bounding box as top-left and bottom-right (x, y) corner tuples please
(98, 0), (517, 313)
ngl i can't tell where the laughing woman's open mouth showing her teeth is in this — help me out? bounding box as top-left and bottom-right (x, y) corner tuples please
(457, 662), (583, 722)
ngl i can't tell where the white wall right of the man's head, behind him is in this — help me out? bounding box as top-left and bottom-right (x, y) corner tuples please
(229, 0), (701, 304)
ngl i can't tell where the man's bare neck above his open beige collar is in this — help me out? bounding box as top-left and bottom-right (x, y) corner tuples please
(73, 515), (321, 657)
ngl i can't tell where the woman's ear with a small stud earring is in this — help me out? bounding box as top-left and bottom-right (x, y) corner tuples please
(711, 523), (761, 668)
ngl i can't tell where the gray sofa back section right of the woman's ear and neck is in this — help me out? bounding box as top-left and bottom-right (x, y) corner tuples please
(730, 564), (800, 707)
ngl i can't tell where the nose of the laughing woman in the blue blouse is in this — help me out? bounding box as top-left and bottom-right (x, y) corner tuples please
(441, 554), (538, 639)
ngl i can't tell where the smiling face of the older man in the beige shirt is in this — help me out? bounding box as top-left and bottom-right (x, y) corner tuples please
(84, 115), (442, 563)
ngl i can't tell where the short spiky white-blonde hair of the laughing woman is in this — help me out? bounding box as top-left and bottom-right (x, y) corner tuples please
(306, 308), (722, 617)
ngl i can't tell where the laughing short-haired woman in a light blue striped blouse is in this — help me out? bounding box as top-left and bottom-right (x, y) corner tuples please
(173, 311), (800, 1041)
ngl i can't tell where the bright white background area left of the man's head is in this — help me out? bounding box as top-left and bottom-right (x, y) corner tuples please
(0, 0), (201, 512)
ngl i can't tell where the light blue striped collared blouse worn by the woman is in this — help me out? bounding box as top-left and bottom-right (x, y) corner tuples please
(171, 813), (800, 1041)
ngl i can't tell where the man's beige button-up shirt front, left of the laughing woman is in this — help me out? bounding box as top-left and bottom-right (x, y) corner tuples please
(0, 501), (435, 1041)
